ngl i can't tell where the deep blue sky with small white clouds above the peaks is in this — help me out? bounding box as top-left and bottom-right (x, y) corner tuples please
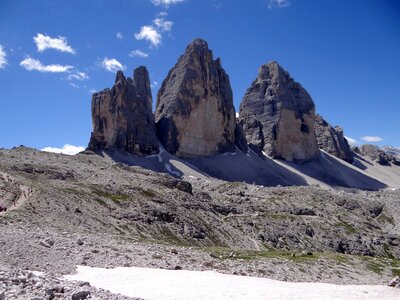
(0, 0), (400, 149)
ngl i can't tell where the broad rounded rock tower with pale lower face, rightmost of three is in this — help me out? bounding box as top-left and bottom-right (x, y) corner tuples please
(240, 62), (319, 162)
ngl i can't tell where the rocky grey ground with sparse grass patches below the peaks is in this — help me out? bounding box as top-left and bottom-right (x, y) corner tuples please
(0, 147), (400, 299)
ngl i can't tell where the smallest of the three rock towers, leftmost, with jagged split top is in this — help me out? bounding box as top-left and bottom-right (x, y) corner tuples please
(88, 67), (158, 155)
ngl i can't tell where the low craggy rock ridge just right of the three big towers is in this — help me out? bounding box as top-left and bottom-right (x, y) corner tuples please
(315, 115), (354, 163)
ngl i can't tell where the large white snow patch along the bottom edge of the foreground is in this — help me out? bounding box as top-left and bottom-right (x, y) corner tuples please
(64, 266), (400, 300)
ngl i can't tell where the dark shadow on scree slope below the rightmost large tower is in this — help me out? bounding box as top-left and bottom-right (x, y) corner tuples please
(282, 151), (387, 190)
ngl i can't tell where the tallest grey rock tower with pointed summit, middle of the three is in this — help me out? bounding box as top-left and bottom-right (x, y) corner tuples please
(155, 39), (236, 157)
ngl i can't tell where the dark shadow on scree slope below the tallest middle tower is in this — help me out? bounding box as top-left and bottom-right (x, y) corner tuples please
(186, 150), (308, 186)
